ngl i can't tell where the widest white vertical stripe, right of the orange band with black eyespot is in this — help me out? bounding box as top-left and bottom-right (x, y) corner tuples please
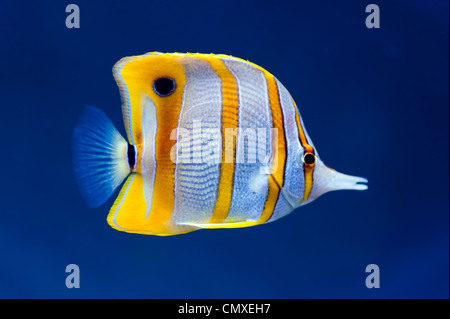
(172, 56), (222, 224)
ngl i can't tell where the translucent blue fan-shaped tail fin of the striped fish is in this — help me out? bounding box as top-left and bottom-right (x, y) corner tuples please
(72, 106), (130, 207)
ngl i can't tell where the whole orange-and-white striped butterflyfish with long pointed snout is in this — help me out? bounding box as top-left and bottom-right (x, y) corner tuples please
(72, 52), (368, 236)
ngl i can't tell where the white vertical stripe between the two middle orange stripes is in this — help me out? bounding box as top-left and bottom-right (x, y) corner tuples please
(222, 58), (272, 222)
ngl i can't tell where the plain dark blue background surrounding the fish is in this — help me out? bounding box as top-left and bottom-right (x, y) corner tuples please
(0, 0), (449, 298)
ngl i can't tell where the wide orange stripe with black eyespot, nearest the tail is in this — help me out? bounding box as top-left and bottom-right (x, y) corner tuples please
(116, 54), (186, 235)
